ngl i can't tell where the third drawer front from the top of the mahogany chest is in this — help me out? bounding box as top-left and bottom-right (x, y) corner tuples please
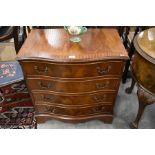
(32, 92), (115, 106)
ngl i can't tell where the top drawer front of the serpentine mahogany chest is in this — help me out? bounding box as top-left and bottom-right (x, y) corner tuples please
(22, 61), (123, 78)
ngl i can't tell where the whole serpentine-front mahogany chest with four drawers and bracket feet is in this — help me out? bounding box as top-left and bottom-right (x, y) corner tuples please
(17, 29), (128, 122)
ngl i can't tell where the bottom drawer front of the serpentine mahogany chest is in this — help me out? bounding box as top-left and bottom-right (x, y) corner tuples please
(35, 104), (112, 116)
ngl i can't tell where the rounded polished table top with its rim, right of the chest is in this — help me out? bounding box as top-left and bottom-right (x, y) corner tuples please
(135, 28), (155, 63)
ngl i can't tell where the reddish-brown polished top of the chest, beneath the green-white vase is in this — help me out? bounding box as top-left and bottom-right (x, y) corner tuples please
(17, 29), (128, 62)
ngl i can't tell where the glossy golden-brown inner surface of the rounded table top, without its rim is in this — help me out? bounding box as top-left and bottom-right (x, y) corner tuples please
(137, 28), (155, 59)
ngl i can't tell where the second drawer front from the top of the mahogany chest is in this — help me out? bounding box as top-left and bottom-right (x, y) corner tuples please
(27, 78), (119, 93)
